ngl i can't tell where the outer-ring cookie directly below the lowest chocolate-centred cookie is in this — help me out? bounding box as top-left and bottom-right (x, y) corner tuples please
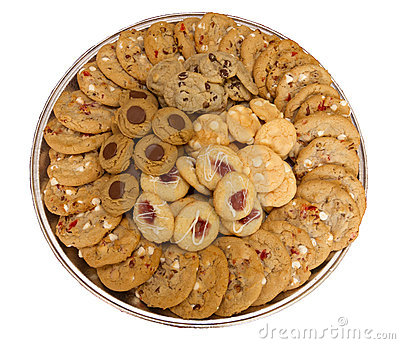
(80, 216), (140, 268)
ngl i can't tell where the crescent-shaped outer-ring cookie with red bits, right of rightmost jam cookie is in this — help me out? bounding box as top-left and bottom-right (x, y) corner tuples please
(267, 198), (333, 269)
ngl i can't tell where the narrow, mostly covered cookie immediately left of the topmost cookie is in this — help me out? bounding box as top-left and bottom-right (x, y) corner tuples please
(174, 17), (200, 59)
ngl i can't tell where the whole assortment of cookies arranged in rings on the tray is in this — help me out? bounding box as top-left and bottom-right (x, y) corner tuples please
(43, 13), (366, 319)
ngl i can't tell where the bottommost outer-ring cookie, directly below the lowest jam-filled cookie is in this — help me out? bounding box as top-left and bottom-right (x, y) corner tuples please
(171, 245), (229, 319)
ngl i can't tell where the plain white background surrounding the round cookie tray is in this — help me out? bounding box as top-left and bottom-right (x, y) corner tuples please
(0, 0), (400, 343)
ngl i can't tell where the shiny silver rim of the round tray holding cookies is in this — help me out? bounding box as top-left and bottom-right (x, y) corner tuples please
(30, 12), (368, 328)
